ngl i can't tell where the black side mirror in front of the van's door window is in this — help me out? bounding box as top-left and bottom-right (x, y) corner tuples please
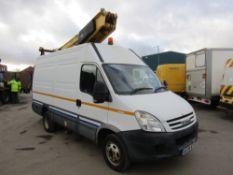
(92, 82), (109, 103)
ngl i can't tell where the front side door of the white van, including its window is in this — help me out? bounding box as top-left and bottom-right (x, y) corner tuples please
(76, 64), (109, 140)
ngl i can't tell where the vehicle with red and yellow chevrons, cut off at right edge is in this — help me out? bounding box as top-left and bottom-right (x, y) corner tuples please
(220, 58), (233, 110)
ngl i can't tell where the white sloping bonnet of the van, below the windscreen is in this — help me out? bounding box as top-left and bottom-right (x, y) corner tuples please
(114, 91), (196, 132)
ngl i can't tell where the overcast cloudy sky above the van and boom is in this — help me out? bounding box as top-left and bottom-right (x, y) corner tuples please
(0, 0), (233, 68)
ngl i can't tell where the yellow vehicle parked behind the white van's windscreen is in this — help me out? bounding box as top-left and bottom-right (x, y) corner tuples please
(155, 64), (185, 95)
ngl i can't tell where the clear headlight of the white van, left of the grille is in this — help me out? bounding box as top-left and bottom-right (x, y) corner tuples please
(135, 111), (166, 132)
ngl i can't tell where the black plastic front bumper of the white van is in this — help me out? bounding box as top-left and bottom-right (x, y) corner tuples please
(119, 122), (198, 161)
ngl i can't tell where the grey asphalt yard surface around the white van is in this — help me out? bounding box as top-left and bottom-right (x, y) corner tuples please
(0, 95), (233, 175)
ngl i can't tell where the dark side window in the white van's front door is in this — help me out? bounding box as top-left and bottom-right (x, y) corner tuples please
(80, 64), (104, 95)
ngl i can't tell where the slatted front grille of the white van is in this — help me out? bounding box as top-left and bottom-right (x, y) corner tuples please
(167, 112), (195, 130)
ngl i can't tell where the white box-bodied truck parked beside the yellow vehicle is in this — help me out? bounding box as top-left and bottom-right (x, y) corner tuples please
(186, 48), (233, 106)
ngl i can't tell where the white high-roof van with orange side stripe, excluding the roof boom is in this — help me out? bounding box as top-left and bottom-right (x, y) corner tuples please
(32, 43), (198, 171)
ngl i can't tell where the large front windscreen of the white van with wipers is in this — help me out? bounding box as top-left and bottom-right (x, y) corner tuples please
(103, 64), (165, 94)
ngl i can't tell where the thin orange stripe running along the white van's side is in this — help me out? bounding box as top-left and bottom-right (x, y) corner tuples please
(33, 91), (134, 116)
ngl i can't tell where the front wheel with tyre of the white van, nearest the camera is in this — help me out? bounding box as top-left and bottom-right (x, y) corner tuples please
(102, 134), (130, 172)
